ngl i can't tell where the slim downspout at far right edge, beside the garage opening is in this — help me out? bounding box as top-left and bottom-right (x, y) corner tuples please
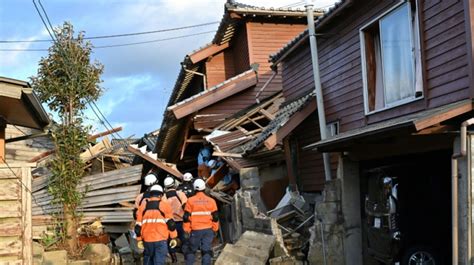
(451, 118), (474, 265)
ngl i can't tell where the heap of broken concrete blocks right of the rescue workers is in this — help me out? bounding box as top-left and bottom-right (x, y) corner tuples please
(214, 168), (315, 264)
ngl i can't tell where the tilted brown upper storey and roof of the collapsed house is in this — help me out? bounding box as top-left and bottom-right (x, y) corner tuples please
(155, 1), (321, 182)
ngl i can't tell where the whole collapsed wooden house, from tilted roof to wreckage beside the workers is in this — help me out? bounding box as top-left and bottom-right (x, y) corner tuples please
(133, 1), (328, 256)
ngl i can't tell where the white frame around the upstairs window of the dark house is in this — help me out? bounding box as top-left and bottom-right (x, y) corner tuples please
(359, 0), (425, 115)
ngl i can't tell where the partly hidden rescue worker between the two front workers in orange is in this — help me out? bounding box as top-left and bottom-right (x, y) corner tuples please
(163, 176), (188, 263)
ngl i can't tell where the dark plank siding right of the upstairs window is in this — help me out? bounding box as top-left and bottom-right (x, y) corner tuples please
(423, 0), (470, 108)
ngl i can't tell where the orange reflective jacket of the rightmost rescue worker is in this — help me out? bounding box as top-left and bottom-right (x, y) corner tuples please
(183, 191), (219, 233)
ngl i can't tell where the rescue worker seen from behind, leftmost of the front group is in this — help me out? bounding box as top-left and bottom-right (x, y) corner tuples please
(135, 185), (178, 265)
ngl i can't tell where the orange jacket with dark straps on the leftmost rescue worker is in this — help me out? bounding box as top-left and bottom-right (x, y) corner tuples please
(137, 197), (178, 242)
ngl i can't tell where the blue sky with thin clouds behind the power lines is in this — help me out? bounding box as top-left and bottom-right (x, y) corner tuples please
(0, 0), (334, 138)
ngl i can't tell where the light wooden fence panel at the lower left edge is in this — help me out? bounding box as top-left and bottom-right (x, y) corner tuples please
(0, 163), (36, 265)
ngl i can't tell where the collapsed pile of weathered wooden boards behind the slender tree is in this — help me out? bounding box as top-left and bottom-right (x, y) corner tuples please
(32, 131), (142, 239)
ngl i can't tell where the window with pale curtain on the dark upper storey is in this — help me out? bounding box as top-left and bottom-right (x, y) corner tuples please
(361, 1), (422, 112)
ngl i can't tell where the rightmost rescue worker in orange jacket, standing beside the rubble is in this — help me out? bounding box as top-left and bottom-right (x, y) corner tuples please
(183, 179), (219, 265)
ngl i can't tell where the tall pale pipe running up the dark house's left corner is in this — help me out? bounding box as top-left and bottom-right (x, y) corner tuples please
(305, 0), (331, 181)
